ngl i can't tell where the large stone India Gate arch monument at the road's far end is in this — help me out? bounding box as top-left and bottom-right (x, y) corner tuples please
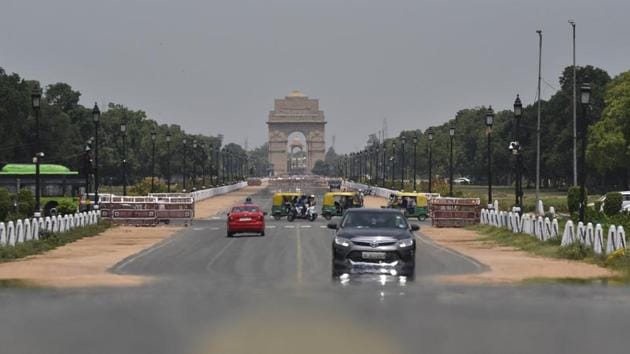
(267, 90), (326, 176)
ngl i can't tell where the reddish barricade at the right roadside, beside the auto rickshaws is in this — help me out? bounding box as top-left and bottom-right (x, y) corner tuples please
(430, 197), (481, 227)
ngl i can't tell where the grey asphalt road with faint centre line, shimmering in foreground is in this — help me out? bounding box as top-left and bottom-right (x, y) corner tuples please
(0, 187), (630, 354)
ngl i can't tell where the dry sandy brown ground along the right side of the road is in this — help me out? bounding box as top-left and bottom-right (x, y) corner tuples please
(365, 196), (614, 284)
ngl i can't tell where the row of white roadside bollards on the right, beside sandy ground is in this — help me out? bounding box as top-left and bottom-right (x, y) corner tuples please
(479, 209), (627, 255)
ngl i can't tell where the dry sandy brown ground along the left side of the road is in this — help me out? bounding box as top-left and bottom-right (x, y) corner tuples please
(0, 187), (263, 288)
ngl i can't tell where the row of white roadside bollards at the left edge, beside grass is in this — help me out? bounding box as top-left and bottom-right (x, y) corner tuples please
(0, 211), (100, 246)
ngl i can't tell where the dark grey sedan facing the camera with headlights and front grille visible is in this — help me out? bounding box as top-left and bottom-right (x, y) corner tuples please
(328, 208), (420, 276)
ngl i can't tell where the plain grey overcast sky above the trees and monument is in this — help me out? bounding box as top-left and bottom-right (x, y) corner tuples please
(0, 0), (630, 152)
